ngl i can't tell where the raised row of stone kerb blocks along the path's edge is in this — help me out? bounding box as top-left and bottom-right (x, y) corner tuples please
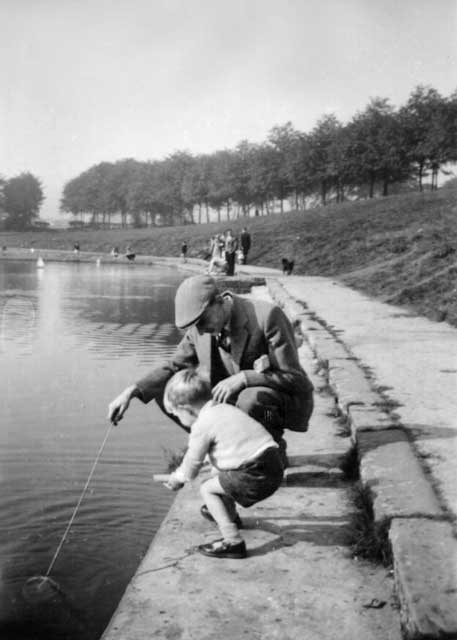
(267, 278), (457, 640)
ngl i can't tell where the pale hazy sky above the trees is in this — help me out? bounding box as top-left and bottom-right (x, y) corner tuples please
(0, 0), (457, 219)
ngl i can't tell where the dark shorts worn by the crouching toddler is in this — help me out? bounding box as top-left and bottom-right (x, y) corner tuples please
(219, 447), (284, 507)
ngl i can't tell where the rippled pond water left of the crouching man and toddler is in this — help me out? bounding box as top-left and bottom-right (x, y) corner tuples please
(0, 261), (185, 640)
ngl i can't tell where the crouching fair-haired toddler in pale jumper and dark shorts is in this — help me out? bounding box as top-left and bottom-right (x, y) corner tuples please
(164, 369), (284, 559)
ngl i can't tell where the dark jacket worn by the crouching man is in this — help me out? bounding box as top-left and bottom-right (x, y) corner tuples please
(136, 294), (313, 427)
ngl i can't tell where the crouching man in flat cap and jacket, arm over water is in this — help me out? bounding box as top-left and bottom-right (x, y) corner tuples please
(108, 275), (313, 460)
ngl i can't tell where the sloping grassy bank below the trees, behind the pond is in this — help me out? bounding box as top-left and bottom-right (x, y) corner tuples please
(0, 189), (457, 326)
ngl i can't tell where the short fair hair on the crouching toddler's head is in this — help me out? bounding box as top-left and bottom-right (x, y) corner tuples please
(163, 368), (211, 413)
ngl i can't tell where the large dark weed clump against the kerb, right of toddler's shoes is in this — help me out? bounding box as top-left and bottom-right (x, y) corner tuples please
(349, 482), (392, 567)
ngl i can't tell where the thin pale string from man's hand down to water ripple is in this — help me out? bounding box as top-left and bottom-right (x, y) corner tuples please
(22, 423), (114, 601)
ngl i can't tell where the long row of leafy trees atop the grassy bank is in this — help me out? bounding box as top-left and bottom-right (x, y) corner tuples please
(61, 86), (457, 226)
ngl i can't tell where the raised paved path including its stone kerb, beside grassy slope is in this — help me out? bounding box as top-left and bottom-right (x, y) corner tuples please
(270, 278), (457, 638)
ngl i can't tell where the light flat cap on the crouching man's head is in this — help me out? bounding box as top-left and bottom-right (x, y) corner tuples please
(175, 275), (218, 329)
